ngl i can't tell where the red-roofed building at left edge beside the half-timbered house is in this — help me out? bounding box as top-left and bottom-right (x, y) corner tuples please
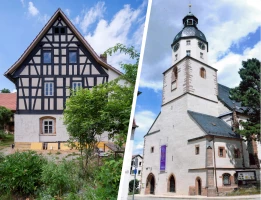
(0, 93), (16, 133)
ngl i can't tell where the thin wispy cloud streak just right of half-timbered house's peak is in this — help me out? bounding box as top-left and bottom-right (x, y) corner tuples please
(80, 1), (106, 33)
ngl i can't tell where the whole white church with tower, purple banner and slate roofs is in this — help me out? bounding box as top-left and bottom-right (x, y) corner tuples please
(141, 12), (260, 196)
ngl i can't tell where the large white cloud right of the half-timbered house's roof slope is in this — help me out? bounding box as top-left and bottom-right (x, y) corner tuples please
(85, 5), (145, 69)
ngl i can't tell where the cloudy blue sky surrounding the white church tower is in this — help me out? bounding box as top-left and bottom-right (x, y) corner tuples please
(133, 0), (261, 155)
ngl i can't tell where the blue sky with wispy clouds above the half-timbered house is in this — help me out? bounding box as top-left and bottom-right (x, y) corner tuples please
(0, 0), (147, 91)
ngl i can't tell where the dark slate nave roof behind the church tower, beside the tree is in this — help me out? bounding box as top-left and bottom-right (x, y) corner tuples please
(218, 84), (247, 113)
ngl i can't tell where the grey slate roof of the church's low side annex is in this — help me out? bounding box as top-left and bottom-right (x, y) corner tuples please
(188, 110), (240, 138)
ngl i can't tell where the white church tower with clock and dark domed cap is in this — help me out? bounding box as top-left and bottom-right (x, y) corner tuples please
(162, 7), (218, 116)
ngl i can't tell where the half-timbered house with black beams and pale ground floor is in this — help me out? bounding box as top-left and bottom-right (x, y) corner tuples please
(5, 9), (121, 150)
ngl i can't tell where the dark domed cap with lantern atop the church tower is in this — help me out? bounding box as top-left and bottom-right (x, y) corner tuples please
(171, 12), (207, 47)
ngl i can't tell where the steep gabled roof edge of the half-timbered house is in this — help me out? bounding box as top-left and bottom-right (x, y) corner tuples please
(4, 8), (122, 81)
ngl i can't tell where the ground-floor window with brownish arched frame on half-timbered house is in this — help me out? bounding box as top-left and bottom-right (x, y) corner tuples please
(40, 116), (56, 135)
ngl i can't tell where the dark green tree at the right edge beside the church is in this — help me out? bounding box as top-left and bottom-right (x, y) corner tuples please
(230, 58), (261, 140)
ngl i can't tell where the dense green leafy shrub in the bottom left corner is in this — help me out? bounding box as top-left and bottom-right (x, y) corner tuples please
(0, 151), (46, 195)
